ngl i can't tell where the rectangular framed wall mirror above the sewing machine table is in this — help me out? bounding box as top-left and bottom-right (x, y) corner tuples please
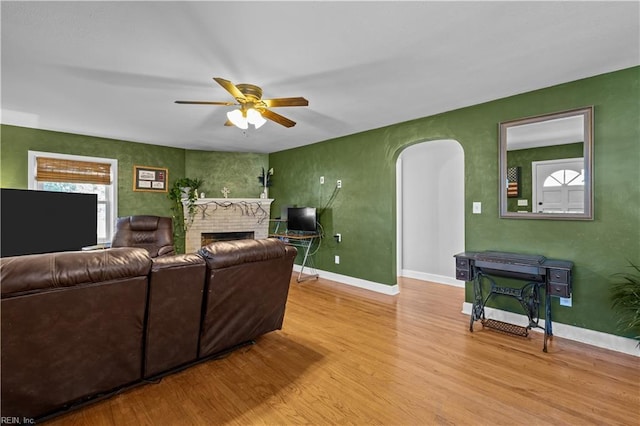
(499, 107), (593, 220)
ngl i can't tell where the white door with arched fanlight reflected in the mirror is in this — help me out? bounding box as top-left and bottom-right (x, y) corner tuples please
(532, 158), (584, 213)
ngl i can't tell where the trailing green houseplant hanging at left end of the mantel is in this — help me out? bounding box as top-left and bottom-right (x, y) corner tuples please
(167, 177), (203, 253)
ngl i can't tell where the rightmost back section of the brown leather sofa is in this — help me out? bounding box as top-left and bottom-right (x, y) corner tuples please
(198, 239), (296, 358)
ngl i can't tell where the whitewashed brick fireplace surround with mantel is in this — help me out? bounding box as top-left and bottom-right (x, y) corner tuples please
(185, 198), (273, 253)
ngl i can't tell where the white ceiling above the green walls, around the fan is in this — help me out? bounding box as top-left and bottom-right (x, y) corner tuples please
(1, 0), (640, 152)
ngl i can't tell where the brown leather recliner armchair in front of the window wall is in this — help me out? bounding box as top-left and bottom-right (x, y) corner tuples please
(111, 216), (175, 257)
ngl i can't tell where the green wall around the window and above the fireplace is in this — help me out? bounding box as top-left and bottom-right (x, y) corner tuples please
(0, 125), (268, 241)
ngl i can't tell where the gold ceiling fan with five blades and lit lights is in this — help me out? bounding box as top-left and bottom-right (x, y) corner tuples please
(176, 77), (309, 129)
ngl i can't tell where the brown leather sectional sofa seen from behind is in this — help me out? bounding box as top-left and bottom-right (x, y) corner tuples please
(0, 239), (296, 420)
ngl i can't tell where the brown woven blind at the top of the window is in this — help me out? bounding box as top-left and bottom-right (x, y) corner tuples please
(36, 157), (111, 185)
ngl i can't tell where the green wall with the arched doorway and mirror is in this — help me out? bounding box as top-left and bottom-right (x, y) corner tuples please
(269, 67), (640, 333)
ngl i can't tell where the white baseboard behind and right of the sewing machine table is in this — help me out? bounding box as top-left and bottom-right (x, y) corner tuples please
(462, 302), (640, 357)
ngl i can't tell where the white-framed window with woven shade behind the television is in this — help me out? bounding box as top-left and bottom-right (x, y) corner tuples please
(28, 151), (118, 243)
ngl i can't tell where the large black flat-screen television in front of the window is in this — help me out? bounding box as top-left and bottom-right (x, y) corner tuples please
(0, 188), (98, 257)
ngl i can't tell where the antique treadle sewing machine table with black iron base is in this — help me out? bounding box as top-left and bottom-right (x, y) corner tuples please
(454, 251), (573, 352)
